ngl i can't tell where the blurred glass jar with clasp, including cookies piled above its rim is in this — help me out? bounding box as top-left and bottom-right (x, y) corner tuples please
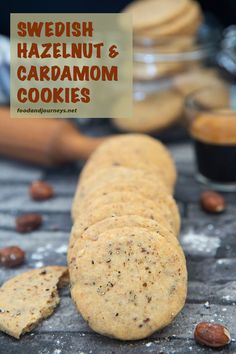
(113, 0), (222, 133)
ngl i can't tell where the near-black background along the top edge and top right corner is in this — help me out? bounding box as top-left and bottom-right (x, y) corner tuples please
(0, 0), (236, 36)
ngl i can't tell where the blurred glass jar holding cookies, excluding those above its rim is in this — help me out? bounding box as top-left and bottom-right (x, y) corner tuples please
(113, 25), (221, 133)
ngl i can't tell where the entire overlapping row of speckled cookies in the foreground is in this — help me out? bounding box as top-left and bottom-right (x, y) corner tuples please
(68, 134), (187, 340)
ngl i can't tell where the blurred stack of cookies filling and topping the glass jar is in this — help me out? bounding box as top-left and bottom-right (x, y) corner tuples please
(112, 0), (203, 133)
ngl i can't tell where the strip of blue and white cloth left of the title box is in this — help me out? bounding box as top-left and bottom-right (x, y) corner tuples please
(0, 36), (10, 104)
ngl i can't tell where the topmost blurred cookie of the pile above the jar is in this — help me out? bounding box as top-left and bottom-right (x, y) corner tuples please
(124, 0), (188, 30)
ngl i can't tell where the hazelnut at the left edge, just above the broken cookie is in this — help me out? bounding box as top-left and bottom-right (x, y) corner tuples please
(0, 246), (25, 268)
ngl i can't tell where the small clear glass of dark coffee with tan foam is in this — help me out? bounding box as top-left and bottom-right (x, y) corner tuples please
(185, 83), (236, 191)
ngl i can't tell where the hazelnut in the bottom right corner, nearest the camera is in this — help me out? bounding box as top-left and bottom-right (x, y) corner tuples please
(194, 322), (231, 348)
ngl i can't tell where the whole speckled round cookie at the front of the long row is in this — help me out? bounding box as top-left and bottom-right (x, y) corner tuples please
(71, 228), (187, 340)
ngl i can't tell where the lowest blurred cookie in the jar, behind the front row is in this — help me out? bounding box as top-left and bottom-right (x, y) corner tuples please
(112, 90), (183, 133)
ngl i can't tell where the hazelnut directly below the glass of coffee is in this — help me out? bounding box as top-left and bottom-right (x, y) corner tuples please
(200, 191), (225, 213)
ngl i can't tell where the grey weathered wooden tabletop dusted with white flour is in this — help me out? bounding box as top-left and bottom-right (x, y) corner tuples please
(0, 144), (236, 354)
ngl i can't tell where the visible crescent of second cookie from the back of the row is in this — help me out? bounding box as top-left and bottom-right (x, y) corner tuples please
(73, 166), (179, 231)
